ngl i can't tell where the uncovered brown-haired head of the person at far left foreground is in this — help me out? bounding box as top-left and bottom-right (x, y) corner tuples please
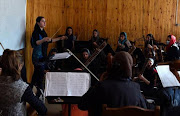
(1, 49), (24, 81)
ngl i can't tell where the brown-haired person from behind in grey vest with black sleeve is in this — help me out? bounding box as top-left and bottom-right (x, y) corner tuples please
(0, 50), (47, 116)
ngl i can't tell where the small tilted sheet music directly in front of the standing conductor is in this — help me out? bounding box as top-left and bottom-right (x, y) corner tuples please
(50, 52), (71, 60)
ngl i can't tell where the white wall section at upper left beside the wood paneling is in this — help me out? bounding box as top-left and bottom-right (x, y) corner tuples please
(0, 0), (26, 55)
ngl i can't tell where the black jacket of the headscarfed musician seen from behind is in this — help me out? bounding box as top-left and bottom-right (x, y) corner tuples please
(79, 79), (147, 115)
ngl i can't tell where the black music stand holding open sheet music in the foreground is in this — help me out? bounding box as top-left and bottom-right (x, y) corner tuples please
(44, 71), (91, 116)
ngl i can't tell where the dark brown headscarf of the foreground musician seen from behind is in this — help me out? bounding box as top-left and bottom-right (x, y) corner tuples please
(109, 51), (133, 79)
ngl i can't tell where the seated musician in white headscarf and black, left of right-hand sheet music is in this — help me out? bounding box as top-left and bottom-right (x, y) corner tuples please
(135, 58), (157, 97)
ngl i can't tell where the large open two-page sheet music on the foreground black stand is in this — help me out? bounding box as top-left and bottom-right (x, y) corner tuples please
(45, 72), (90, 96)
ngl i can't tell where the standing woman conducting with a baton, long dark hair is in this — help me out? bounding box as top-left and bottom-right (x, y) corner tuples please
(31, 16), (66, 97)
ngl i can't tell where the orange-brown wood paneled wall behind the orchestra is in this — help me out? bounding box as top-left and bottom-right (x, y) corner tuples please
(26, 0), (180, 81)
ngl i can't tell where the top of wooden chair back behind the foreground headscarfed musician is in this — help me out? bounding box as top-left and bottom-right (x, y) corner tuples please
(102, 105), (160, 116)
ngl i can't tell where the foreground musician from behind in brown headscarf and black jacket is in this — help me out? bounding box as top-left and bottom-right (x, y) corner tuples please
(79, 51), (151, 116)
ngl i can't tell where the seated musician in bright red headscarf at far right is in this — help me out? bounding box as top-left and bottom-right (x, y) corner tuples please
(165, 35), (180, 61)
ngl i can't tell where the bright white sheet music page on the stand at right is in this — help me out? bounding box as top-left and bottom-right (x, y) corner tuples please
(156, 65), (180, 87)
